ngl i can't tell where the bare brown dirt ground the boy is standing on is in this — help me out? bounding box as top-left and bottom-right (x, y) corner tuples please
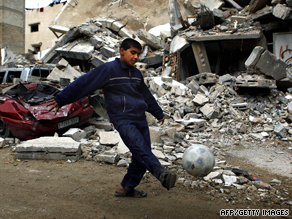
(0, 145), (292, 219)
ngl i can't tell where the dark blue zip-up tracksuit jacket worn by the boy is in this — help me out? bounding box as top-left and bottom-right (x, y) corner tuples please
(54, 58), (164, 122)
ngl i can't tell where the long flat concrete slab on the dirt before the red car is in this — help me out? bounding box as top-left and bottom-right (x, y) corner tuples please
(15, 137), (81, 160)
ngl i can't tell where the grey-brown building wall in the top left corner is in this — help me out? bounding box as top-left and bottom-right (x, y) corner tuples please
(0, 0), (25, 54)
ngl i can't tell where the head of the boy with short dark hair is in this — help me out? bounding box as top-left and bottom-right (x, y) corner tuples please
(120, 38), (142, 66)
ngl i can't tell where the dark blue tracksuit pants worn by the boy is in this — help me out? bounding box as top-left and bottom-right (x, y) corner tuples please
(113, 119), (164, 191)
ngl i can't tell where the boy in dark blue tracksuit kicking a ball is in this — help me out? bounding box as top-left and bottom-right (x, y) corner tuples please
(48, 38), (176, 198)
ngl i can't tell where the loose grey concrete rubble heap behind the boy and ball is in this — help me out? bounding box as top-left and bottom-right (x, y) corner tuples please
(8, 70), (292, 206)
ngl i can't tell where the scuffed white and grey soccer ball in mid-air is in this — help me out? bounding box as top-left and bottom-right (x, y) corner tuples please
(182, 144), (215, 176)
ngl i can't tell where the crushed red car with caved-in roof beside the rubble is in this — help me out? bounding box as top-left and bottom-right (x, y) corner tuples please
(0, 82), (93, 139)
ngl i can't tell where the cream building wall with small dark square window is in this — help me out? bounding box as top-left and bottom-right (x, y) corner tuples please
(25, 4), (64, 53)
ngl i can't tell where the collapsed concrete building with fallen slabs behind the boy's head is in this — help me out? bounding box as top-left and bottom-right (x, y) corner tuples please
(22, 0), (291, 93)
